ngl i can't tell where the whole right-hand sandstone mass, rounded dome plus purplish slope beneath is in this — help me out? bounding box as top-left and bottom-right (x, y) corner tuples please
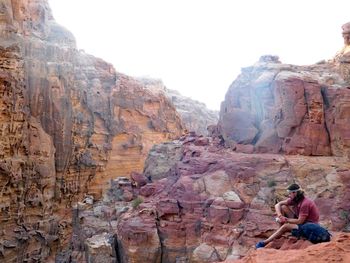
(67, 56), (350, 262)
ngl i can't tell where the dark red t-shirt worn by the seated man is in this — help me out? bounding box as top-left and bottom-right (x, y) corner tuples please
(287, 197), (320, 223)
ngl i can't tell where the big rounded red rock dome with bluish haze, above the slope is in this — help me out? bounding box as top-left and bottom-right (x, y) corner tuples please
(218, 57), (350, 156)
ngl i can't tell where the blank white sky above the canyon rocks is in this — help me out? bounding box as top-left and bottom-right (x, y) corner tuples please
(49, 0), (350, 109)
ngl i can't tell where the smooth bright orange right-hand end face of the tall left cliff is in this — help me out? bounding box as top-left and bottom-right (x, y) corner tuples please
(102, 74), (184, 197)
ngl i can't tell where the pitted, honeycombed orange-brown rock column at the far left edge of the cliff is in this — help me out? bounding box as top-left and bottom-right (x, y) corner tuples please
(0, 35), (61, 262)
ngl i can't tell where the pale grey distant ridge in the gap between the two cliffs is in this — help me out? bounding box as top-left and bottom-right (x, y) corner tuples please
(139, 78), (219, 135)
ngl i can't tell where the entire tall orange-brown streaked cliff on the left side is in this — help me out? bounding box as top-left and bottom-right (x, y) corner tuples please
(0, 0), (183, 262)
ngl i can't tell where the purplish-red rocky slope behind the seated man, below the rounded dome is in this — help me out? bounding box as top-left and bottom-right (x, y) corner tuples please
(69, 135), (350, 262)
